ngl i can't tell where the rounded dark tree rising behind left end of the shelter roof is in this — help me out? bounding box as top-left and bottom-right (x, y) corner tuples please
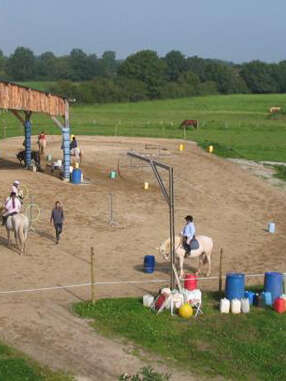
(6, 46), (36, 81)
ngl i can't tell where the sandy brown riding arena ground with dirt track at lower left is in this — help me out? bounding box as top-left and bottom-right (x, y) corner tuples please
(0, 136), (286, 380)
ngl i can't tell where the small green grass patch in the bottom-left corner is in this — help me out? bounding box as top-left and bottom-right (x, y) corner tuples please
(0, 343), (74, 381)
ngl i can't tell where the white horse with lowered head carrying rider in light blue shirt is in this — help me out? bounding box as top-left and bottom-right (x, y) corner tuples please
(159, 235), (213, 278)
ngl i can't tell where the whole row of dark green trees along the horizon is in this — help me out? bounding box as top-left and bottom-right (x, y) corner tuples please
(0, 47), (286, 103)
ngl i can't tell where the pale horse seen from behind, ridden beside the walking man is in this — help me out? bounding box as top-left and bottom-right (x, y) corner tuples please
(0, 206), (29, 255)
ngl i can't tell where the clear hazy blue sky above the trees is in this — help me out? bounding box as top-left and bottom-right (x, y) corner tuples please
(0, 0), (286, 63)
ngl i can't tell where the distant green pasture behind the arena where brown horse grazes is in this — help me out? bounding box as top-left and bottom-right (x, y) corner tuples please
(0, 94), (286, 161)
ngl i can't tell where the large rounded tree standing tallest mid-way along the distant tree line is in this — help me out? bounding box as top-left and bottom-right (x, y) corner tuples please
(118, 50), (167, 98)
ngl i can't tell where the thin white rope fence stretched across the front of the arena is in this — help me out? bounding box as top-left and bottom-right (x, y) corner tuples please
(0, 273), (264, 295)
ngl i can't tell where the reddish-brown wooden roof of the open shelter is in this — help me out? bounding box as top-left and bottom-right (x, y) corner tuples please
(0, 81), (66, 116)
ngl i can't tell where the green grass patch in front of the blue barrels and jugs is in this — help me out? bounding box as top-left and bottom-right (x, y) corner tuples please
(74, 293), (286, 381)
